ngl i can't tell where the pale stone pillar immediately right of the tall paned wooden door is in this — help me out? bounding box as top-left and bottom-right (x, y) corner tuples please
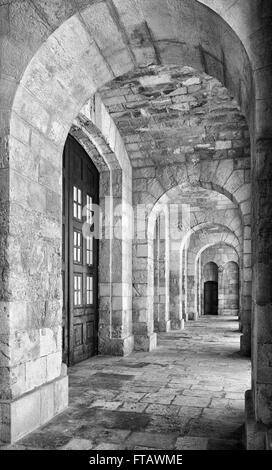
(99, 169), (134, 356)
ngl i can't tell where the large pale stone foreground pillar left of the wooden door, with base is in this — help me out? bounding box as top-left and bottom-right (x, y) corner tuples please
(0, 126), (68, 443)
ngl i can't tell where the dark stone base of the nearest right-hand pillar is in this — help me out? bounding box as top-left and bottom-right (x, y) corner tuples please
(244, 390), (268, 450)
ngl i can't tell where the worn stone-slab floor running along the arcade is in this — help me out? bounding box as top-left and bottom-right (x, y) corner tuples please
(2, 317), (250, 450)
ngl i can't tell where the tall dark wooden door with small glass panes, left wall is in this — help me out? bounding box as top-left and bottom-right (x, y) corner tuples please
(62, 135), (99, 365)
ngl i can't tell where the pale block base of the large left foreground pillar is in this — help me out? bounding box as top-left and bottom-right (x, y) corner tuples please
(0, 367), (68, 444)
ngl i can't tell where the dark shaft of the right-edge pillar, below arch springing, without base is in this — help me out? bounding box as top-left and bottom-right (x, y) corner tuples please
(252, 139), (272, 426)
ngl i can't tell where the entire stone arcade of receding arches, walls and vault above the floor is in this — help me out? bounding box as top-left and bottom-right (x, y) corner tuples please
(0, 0), (272, 449)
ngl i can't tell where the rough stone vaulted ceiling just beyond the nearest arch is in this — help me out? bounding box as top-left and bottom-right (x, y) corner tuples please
(100, 65), (249, 167)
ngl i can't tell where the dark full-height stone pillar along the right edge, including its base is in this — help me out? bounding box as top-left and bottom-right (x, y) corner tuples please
(243, 9), (272, 449)
